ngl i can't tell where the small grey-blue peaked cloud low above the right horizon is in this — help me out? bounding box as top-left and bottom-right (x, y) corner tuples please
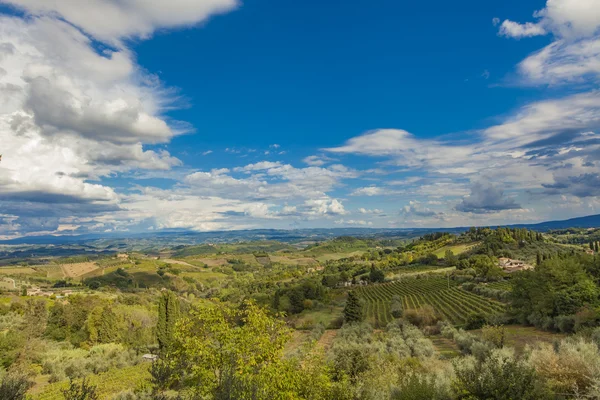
(456, 182), (521, 214)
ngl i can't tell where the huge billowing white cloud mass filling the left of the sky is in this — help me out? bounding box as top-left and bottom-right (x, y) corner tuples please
(0, 0), (236, 235)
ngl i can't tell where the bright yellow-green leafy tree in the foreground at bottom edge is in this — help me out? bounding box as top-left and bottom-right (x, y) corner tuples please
(153, 302), (298, 400)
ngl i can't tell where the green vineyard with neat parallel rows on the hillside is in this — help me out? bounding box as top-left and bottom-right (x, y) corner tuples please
(356, 277), (505, 326)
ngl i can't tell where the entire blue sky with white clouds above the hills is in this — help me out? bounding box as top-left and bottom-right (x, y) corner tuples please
(0, 0), (600, 238)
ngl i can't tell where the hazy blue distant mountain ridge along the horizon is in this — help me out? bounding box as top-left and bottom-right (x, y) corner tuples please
(0, 214), (600, 248)
